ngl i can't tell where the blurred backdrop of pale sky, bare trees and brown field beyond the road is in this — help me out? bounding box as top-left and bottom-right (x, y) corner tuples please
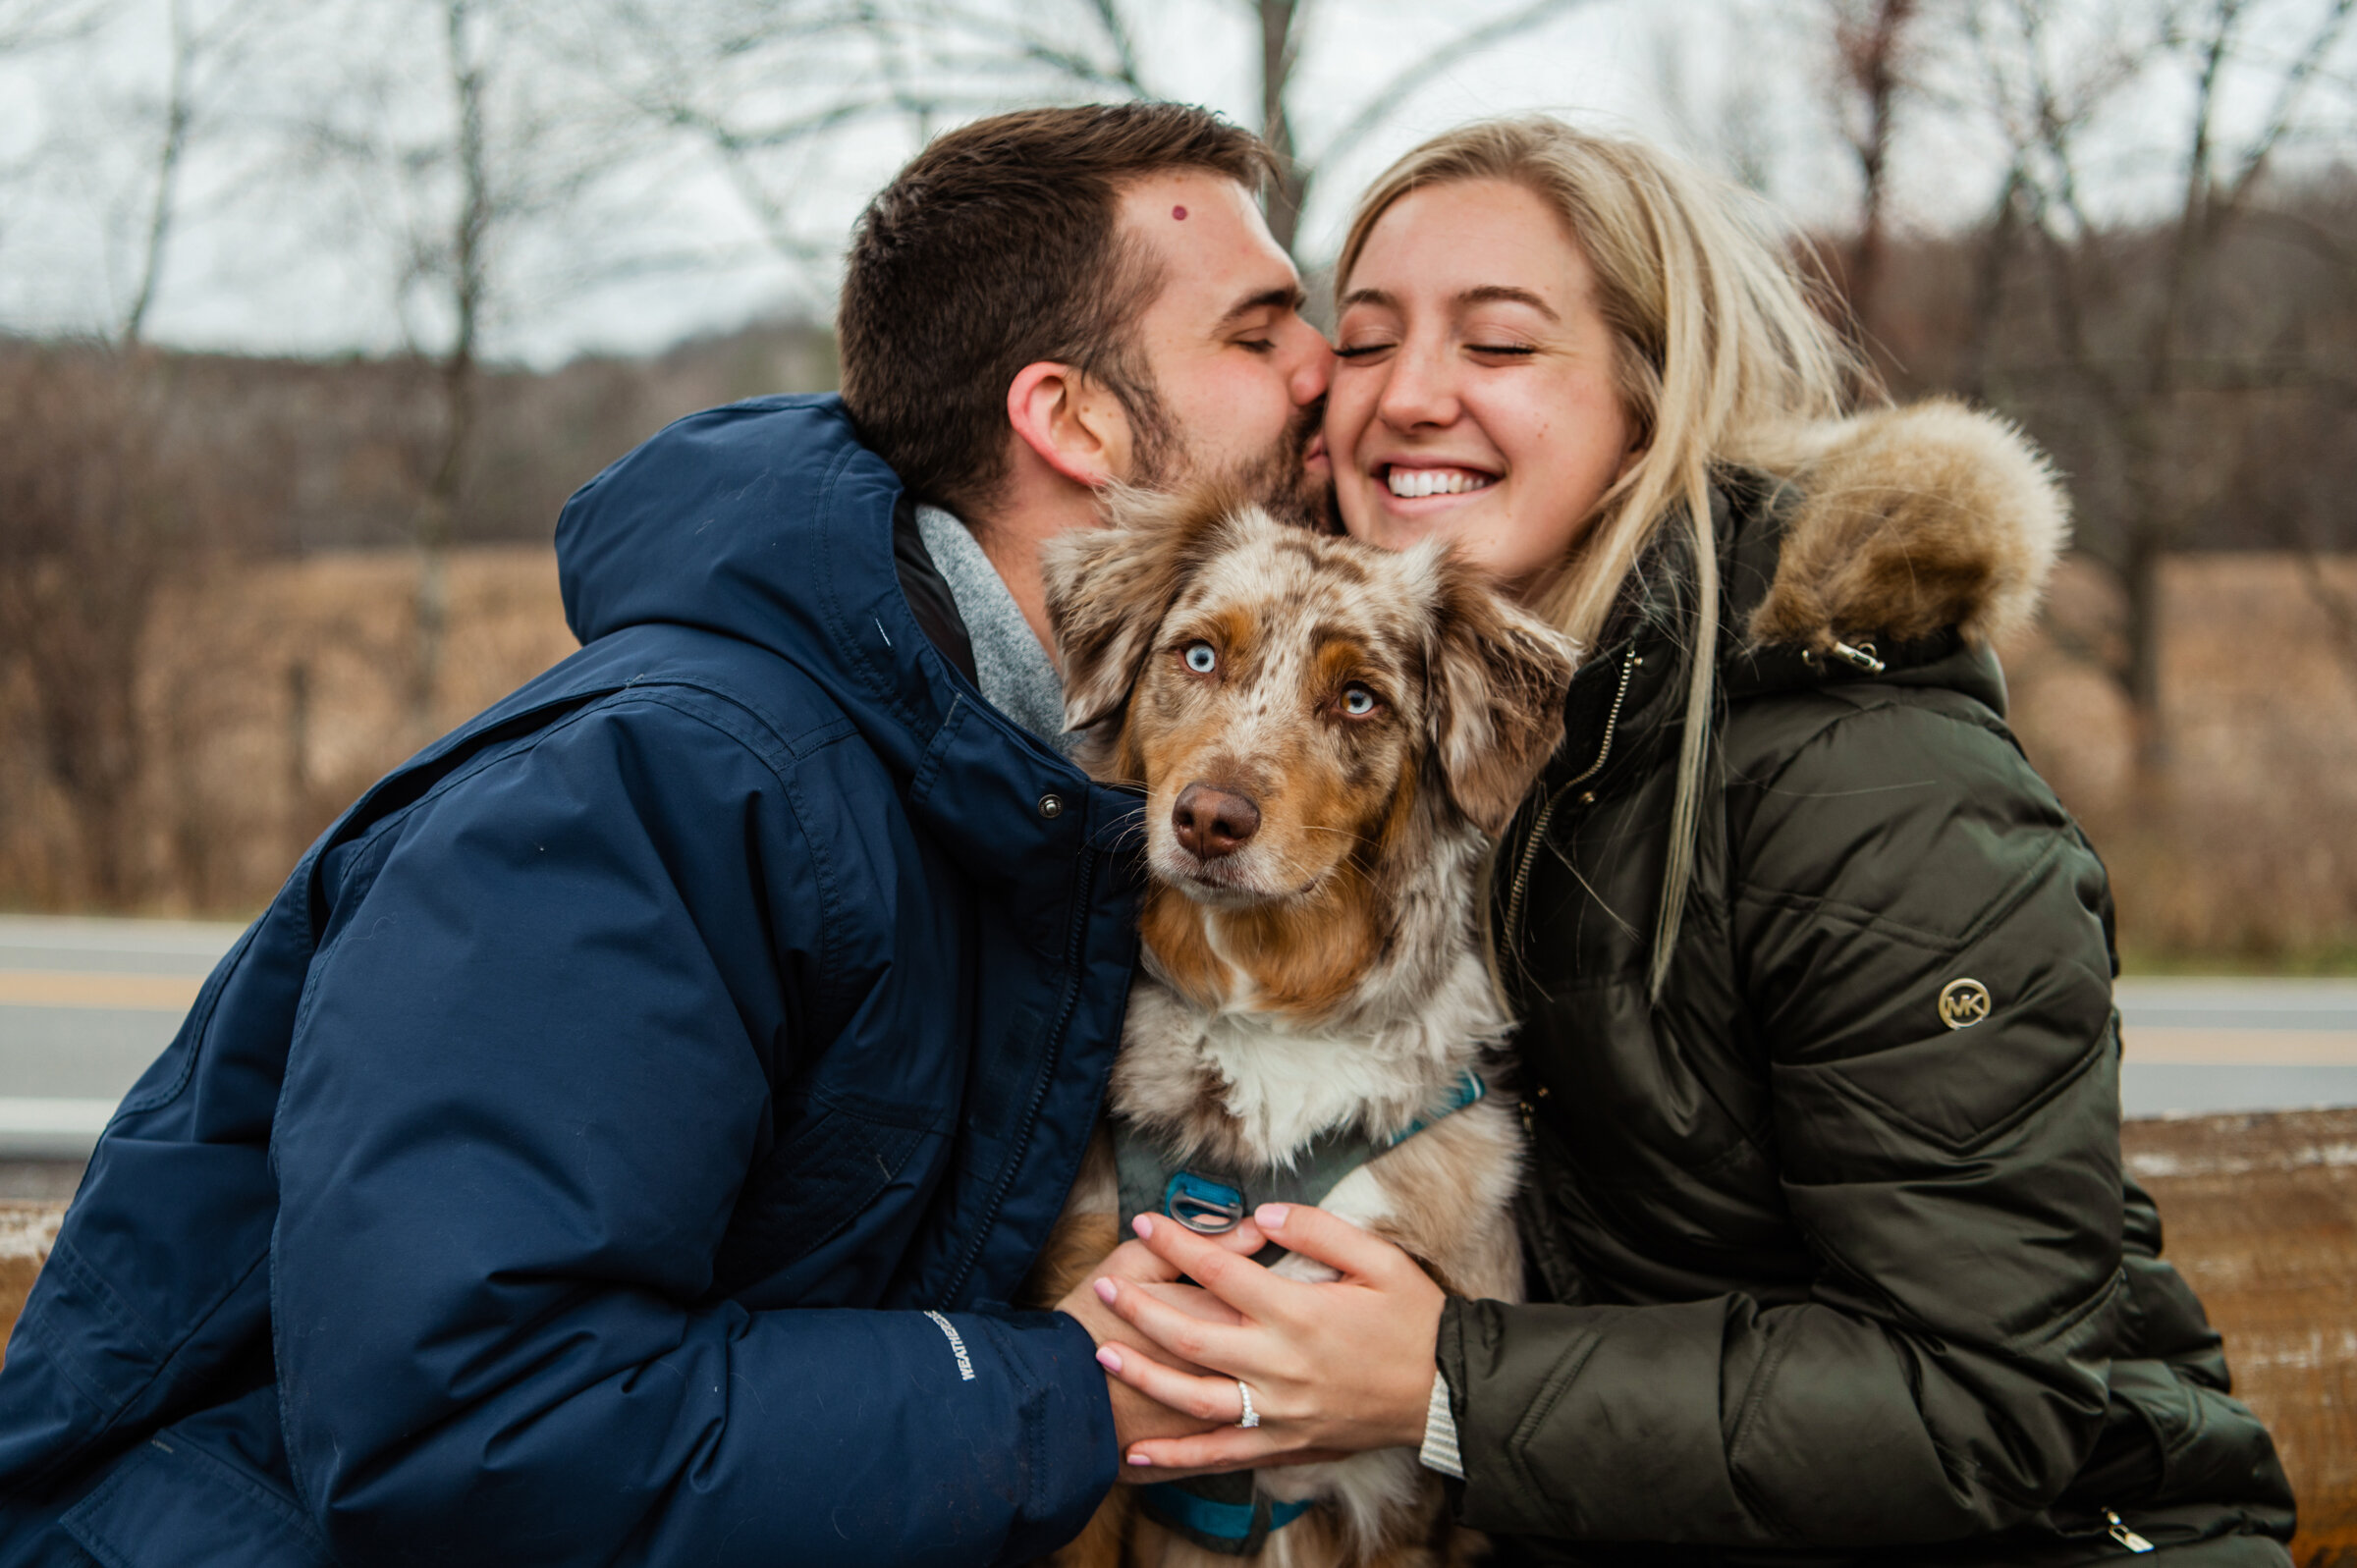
(0, 0), (2357, 974)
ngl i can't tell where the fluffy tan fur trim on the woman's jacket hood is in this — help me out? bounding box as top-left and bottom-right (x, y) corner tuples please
(1746, 399), (2069, 653)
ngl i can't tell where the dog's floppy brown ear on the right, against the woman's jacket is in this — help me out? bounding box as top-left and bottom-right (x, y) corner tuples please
(1426, 554), (1579, 838)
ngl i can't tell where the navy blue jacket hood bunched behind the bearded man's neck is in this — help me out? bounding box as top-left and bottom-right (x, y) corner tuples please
(556, 394), (1077, 783)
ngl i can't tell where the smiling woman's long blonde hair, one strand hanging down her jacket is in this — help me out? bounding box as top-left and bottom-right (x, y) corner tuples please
(1334, 116), (1879, 998)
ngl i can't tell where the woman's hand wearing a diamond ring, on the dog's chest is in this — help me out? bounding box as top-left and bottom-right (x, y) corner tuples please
(1094, 1203), (1445, 1481)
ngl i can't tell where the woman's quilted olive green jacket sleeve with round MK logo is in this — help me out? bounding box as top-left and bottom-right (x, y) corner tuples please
(1440, 693), (2121, 1546)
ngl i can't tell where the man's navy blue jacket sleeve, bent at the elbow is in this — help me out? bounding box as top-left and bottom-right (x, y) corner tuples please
(273, 693), (1113, 1568)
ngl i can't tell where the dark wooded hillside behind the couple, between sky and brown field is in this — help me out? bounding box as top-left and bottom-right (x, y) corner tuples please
(0, 190), (2357, 559)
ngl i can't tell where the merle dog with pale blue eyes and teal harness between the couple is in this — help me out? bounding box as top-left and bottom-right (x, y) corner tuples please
(1032, 493), (1574, 1568)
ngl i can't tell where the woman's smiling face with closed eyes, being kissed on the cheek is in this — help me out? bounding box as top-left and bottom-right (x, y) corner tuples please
(1325, 180), (1636, 599)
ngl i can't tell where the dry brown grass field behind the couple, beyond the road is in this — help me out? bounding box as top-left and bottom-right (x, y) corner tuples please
(0, 545), (2357, 967)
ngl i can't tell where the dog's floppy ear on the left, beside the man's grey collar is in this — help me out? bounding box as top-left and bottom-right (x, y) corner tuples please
(1039, 488), (1233, 729)
